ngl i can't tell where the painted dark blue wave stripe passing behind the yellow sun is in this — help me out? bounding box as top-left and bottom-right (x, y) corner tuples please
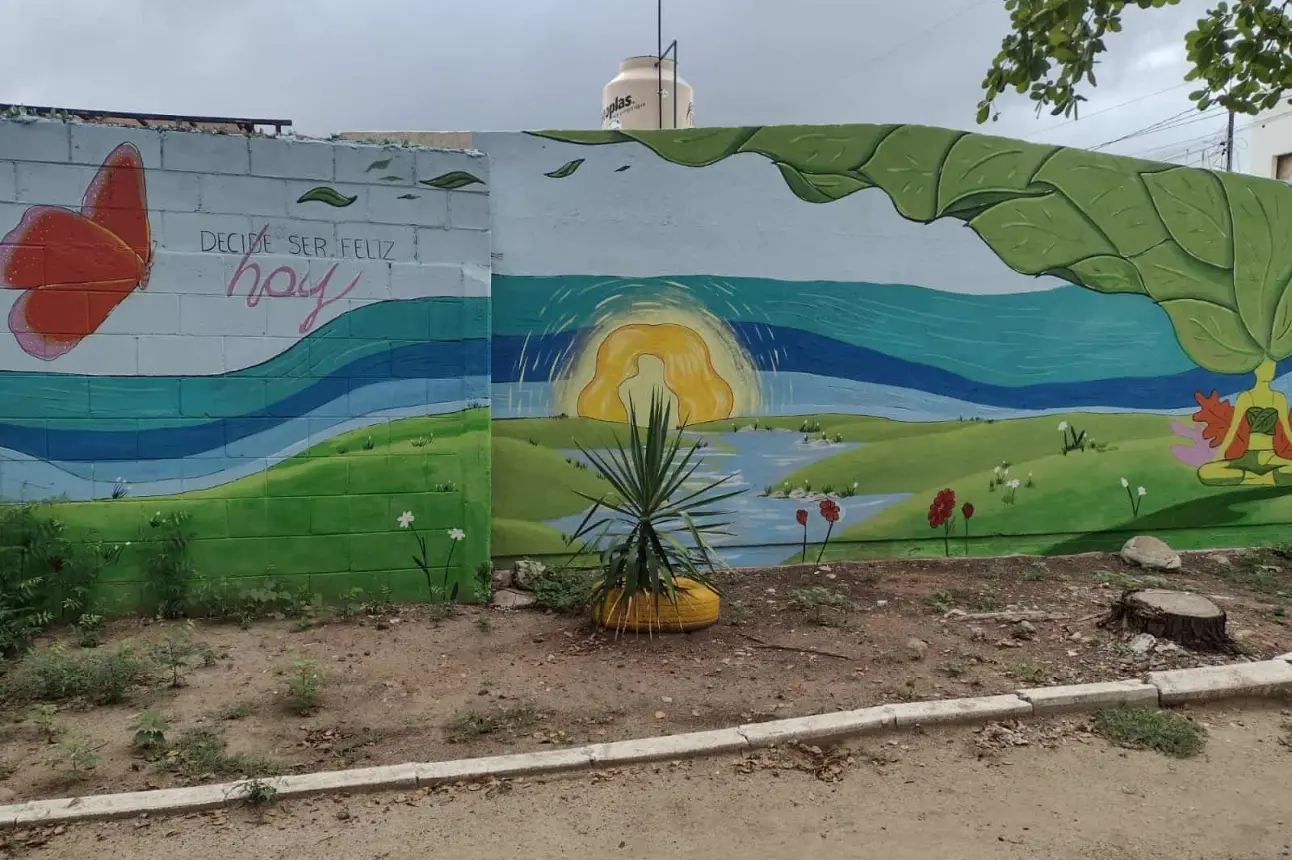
(494, 323), (1266, 409)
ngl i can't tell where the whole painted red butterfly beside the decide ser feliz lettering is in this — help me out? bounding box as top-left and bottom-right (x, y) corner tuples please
(0, 143), (152, 362)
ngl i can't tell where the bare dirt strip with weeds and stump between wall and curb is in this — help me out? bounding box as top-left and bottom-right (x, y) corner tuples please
(0, 553), (1292, 805)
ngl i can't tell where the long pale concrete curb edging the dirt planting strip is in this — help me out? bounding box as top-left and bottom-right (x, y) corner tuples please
(0, 653), (1292, 828)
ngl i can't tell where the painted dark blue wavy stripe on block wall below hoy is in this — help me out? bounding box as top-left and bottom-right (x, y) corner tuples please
(0, 338), (490, 462)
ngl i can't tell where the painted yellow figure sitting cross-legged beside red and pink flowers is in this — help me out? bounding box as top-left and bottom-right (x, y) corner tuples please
(1194, 362), (1292, 487)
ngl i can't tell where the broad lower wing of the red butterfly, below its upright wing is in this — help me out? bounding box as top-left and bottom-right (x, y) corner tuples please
(0, 207), (146, 362)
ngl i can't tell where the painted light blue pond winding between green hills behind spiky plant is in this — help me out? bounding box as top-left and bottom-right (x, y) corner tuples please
(548, 431), (907, 567)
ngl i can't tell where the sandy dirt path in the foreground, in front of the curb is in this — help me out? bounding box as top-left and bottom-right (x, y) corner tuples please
(25, 709), (1292, 860)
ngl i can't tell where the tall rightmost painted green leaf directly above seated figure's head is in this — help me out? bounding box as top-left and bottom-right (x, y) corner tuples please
(1220, 173), (1292, 359)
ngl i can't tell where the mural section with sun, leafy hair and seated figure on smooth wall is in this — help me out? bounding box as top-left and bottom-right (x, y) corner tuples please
(487, 125), (1292, 564)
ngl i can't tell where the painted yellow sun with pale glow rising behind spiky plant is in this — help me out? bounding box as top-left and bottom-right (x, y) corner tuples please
(557, 306), (758, 424)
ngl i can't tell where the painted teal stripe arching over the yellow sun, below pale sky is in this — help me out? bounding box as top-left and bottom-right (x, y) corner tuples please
(492, 275), (1195, 386)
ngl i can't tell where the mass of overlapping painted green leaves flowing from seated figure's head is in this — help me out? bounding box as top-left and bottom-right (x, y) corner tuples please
(521, 125), (1292, 373)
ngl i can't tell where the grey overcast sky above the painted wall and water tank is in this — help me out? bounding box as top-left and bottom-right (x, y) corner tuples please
(0, 0), (1251, 164)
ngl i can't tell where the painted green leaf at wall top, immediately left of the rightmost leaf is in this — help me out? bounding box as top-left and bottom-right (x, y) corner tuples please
(1143, 168), (1234, 269)
